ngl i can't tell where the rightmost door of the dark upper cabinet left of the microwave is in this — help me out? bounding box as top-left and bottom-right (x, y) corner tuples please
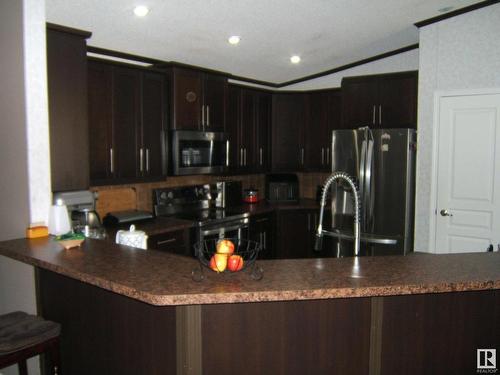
(139, 73), (167, 181)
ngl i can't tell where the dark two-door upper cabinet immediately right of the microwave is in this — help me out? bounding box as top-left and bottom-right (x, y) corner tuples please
(226, 85), (271, 173)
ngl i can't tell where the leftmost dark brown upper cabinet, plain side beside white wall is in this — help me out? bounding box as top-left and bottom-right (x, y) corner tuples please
(47, 24), (91, 191)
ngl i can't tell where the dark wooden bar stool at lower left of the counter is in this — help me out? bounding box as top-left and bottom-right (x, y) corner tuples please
(0, 311), (61, 375)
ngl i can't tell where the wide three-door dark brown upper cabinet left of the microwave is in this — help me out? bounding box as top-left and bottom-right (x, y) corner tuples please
(88, 60), (167, 185)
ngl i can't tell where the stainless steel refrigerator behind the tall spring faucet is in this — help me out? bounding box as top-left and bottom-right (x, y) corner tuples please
(328, 128), (416, 256)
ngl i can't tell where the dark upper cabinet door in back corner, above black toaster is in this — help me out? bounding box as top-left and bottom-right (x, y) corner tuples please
(272, 94), (306, 172)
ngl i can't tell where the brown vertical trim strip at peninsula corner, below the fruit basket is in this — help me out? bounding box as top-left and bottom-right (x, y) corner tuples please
(175, 305), (203, 375)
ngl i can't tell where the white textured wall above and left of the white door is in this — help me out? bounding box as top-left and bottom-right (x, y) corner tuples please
(415, 4), (500, 251)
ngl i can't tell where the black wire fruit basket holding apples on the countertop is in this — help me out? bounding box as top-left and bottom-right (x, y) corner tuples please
(192, 238), (263, 281)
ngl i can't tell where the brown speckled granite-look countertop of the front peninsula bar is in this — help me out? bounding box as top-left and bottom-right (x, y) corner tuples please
(0, 238), (500, 306)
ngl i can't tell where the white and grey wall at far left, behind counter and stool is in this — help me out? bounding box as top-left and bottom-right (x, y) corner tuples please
(0, 0), (51, 375)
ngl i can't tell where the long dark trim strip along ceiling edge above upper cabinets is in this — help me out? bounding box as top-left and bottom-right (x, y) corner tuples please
(87, 44), (418, 92)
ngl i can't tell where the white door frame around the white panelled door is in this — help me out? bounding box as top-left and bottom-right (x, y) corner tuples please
(428, 87), (500, 253)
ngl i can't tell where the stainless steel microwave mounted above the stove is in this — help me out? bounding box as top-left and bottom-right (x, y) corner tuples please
(172, 130), (229, 175)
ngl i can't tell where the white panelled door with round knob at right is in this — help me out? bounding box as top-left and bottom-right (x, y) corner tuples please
(435, 94), (500, 253)
